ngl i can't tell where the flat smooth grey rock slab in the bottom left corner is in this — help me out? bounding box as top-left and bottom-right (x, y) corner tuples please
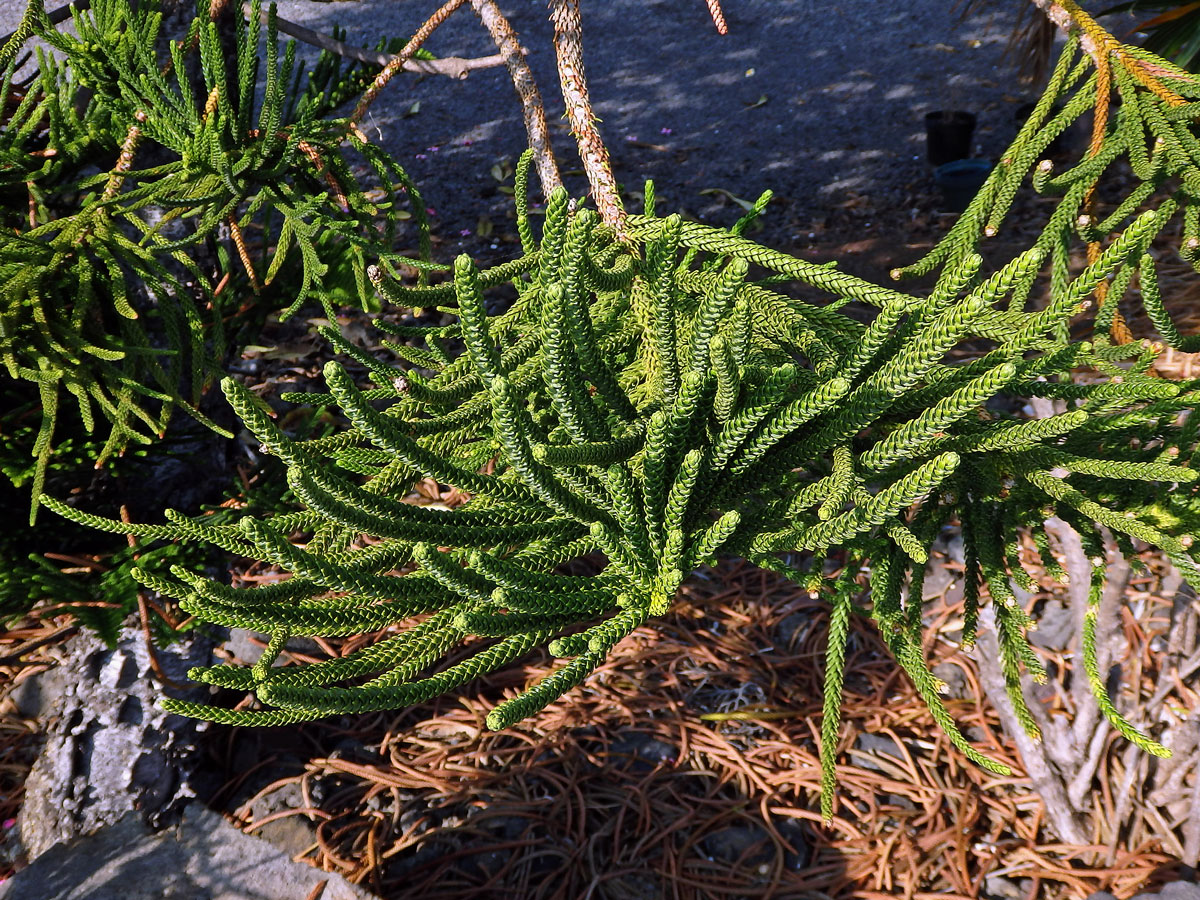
(0, 803), (372, 900)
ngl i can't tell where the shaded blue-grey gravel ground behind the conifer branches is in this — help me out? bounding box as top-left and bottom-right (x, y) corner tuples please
(0, 0), (1030, 256)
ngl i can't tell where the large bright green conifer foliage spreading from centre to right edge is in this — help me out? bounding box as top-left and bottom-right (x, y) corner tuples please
(43, 26), (1200, 814)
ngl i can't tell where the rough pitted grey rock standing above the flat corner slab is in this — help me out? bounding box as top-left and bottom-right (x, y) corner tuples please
(14, 629), (212, 859)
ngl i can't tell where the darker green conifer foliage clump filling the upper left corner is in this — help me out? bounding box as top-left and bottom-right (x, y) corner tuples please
(0, 0), (427, 520)
